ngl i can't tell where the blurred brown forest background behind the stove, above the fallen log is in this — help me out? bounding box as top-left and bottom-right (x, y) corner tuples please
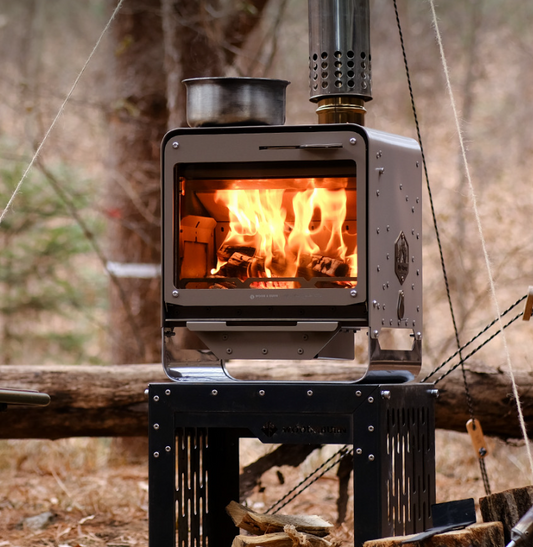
(0, 0), (533, 540)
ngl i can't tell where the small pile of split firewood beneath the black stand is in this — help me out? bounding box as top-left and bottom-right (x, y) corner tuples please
(226, 501), (335, 547)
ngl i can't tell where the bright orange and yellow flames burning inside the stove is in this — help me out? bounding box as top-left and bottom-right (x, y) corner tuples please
(211, 180), (357, 288)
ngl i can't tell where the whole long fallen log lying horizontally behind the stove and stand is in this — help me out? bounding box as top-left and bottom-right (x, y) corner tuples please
(0, 362), (533, 439)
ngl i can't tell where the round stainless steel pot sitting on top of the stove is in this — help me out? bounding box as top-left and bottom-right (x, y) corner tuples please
(183, 78), (290, 127)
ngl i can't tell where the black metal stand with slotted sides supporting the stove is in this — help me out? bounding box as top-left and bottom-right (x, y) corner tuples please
(149, 382), (436, 547)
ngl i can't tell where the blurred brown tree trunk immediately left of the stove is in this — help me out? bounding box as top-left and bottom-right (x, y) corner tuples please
(107, 0), (167, 363)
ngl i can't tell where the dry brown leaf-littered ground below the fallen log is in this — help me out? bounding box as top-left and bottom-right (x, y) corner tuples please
(0, 431), (531, 547)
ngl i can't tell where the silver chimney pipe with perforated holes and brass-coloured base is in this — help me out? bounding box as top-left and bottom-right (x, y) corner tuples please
(309, 0), (372, 125)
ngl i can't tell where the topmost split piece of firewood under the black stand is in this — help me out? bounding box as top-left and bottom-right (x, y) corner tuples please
(226, 501), (333, 545)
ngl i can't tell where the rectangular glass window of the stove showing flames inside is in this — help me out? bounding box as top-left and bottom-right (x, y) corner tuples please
(174, 161), (357, 289)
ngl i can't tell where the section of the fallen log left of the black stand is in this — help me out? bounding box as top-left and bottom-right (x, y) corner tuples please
(0, 365), (168, 439)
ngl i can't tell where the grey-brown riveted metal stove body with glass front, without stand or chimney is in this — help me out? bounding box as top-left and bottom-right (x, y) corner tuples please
(162, 124), (422, 382)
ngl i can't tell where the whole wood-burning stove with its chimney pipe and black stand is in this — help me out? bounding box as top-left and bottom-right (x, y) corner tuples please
(149, 0), (437, 547)
